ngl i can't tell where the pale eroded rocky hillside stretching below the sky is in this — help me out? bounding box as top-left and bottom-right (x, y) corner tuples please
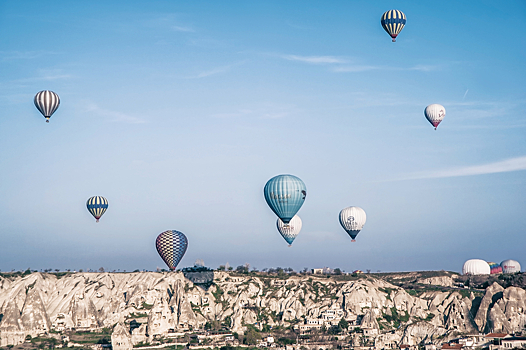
(0, 272), (526, 346)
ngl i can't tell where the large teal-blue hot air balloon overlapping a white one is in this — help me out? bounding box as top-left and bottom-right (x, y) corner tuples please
(263, 175), (307, 224)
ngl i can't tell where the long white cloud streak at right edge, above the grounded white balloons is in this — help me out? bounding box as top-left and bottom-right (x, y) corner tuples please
(395, 156), (526, 181)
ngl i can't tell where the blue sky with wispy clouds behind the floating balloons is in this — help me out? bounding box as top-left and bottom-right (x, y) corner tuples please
(0, 0), (526, 272)
